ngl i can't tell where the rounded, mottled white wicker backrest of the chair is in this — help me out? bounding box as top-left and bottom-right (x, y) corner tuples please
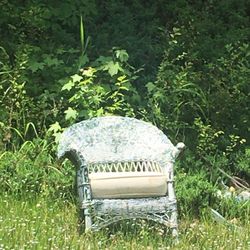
(58, 116), (179, 172)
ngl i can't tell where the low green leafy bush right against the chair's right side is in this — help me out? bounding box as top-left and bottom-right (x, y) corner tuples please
(175, 150), (217, 217)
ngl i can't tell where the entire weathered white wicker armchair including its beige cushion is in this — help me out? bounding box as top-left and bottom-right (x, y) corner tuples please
(58, 116), (184, 236)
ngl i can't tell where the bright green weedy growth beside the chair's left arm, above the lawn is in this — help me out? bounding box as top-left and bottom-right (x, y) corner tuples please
(0, 141), (75, 198)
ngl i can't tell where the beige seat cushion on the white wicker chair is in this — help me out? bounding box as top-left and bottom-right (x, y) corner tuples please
(89, 172), (167, 198)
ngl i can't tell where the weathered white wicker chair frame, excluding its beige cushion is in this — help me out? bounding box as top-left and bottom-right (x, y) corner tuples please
(58, 116), (184, 236)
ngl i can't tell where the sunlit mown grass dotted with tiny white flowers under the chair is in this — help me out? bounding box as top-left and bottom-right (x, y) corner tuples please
(0, 195), (250, 250)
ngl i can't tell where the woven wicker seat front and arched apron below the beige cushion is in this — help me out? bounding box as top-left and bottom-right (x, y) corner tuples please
(92, 197), (177, 231)
